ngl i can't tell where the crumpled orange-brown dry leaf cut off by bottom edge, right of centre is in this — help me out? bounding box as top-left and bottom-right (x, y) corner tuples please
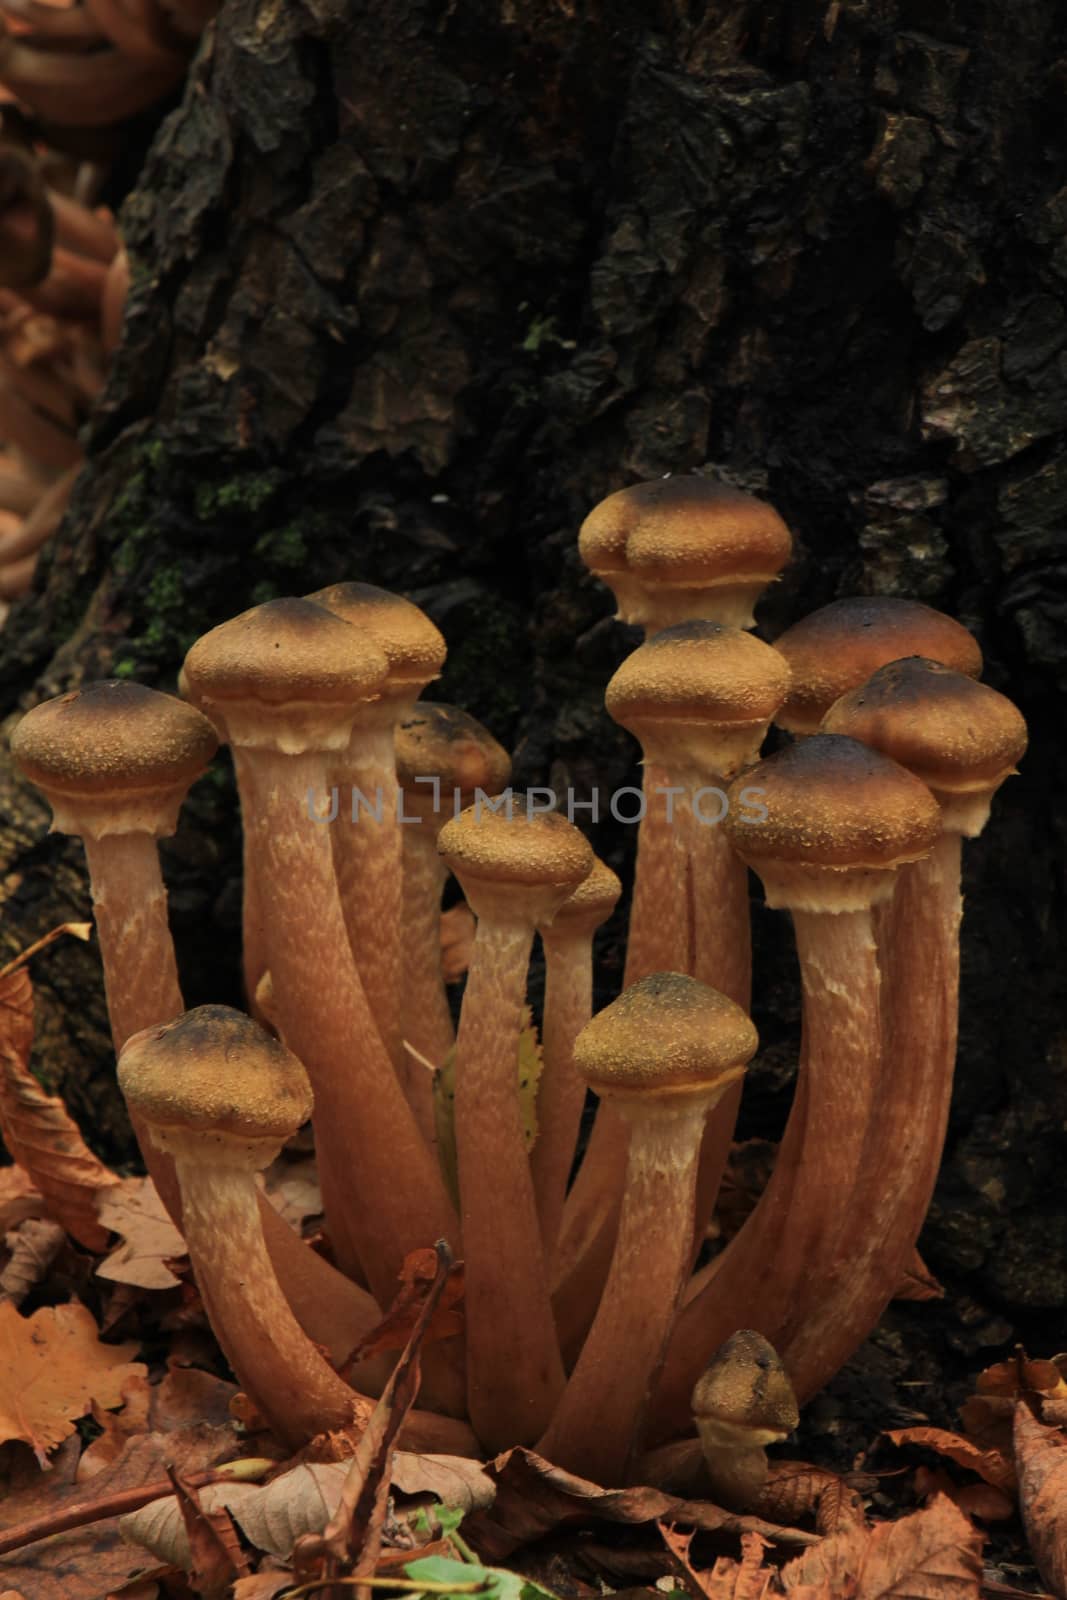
(782, 1496), (982, 1600)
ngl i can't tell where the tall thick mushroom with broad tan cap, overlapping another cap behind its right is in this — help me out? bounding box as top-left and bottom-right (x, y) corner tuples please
(186, 600), (456, 1306)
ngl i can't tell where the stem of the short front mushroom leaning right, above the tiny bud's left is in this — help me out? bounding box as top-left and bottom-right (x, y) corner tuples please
(537, 1102), (707, 1485)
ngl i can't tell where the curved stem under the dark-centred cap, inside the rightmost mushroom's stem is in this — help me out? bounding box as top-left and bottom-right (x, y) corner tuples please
(656, 910), (881, 1438)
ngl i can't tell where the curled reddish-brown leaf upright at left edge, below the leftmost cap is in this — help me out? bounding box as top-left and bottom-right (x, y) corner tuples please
(0, 966), (118, 1250)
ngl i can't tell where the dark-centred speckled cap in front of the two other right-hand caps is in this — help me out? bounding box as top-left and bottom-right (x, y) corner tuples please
(725, 733), (941, 912)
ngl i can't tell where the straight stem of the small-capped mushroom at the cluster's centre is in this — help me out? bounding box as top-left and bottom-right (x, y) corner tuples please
(456, 915), (563, 1450)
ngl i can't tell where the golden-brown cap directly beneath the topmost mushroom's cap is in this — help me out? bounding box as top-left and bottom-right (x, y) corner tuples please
(605, 622), (789, 776)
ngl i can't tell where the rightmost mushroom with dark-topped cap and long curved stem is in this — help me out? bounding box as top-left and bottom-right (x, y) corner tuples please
(782, 656), (1027, 1397)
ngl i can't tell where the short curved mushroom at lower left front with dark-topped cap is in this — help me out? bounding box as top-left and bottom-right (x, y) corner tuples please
(118, 1006), (479, 1450)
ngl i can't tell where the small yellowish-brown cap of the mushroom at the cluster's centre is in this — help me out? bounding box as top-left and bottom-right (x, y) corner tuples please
(437, 806), (593, 893)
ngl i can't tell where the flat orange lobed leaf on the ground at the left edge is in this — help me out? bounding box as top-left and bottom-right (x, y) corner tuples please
(0, 1302), (146, 1466)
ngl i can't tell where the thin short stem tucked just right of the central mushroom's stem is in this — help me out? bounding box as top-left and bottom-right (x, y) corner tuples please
(530, 926), (593, 1270)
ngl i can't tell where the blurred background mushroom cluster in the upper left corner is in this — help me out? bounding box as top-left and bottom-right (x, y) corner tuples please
(0, 0), (219, 619)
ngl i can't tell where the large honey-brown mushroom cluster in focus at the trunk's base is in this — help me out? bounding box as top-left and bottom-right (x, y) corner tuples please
(13, 475), (1025, 1506)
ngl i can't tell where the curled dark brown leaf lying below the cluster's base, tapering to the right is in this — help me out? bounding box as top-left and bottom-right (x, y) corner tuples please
(464, 1450), (817, 1563)
